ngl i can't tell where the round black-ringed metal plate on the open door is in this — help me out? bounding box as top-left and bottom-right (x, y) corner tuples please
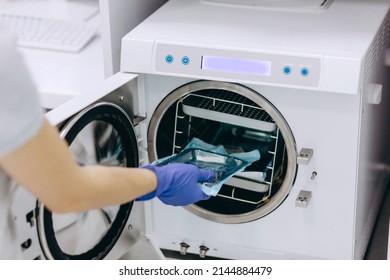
(36, 102), (139, 259)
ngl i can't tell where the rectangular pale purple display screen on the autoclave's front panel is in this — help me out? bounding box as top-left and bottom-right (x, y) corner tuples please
(201, 55), (271, 76)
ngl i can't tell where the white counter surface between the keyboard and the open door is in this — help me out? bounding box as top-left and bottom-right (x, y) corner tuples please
(20, 36), (104, 109)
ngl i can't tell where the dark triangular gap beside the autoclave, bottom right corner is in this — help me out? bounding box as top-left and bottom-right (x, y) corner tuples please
(365, 187), (390, 260)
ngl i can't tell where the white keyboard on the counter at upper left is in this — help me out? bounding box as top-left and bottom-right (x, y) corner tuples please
(0, 12), (97, 52)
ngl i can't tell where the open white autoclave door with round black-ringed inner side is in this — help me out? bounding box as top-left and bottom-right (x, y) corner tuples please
(13, 74), (163, 260)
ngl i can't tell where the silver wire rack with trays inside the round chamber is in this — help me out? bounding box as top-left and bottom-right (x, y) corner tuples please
(172, 93), (280, 205)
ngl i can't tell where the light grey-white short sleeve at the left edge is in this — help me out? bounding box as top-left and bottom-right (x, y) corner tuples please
(0, 27), (44, 156)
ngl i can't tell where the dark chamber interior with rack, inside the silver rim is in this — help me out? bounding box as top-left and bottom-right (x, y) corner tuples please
(155, 88), (288, 218)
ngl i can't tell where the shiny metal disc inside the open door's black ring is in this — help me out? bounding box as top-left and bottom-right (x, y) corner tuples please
(53, 121), (126, 255)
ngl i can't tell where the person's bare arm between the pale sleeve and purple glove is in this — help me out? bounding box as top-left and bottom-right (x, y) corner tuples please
(0, 119), (157, 213)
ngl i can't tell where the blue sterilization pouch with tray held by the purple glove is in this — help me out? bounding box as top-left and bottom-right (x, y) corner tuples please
(153, 138), (260, 196)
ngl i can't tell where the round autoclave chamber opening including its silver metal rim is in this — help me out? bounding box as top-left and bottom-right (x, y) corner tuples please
(148, 81), (297, 223)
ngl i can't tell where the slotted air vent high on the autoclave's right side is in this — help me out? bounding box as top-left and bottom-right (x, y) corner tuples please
(364, 20), (390, 80)
